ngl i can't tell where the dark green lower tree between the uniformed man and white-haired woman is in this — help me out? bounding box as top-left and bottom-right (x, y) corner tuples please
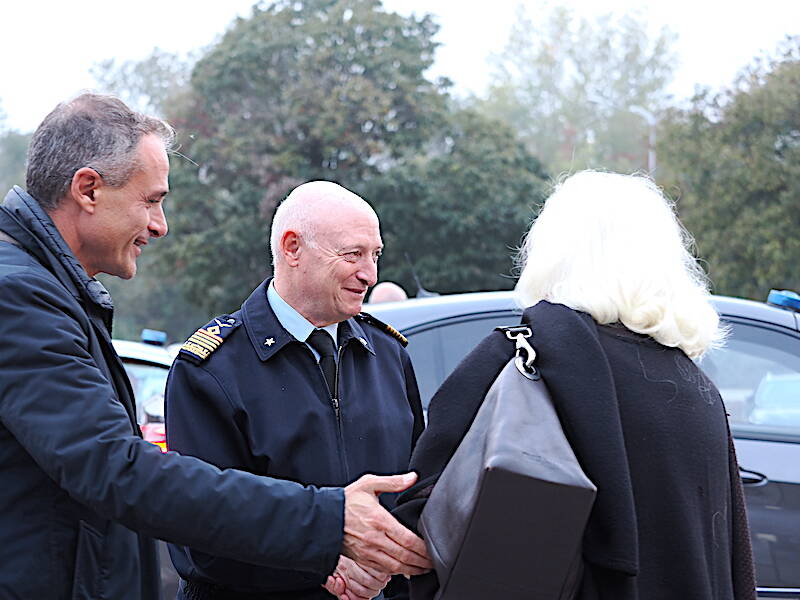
(362, 110), (547, 294)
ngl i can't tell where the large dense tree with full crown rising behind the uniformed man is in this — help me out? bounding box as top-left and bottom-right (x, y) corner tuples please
(154, 0), (454, 312)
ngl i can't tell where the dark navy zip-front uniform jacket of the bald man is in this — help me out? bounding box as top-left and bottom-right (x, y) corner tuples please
(166, 281), (423, 598)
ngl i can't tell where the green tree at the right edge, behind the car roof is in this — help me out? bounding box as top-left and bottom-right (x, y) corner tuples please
(659, 36), (800, 300)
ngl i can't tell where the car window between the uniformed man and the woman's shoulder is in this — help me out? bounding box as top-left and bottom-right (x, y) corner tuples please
(408, 312), (519, 411)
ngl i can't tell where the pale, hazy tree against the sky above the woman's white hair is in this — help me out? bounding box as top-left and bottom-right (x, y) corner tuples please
(476, 6), (675, 172)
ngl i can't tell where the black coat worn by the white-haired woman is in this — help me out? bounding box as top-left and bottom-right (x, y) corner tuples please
(395, 302), (755, 600)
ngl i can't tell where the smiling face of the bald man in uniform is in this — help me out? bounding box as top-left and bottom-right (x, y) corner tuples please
(287, 203), (383, 327)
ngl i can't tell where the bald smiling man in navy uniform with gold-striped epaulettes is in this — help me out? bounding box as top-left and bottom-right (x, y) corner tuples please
(166, 181), (423, 600)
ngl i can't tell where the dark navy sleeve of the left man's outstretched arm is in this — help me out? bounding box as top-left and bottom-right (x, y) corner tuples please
(0, 270), (344, 572)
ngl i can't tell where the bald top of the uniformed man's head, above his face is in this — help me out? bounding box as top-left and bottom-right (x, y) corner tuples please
(269, 181), (378, 267)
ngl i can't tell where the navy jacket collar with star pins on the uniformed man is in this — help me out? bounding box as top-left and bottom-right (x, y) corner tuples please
(241, 277), (375, 360)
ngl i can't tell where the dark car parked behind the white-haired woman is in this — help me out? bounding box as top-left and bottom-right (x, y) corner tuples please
(364, 292), (800, 599)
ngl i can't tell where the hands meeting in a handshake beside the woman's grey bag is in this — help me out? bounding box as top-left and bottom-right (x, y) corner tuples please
(324, 473), (432, 600)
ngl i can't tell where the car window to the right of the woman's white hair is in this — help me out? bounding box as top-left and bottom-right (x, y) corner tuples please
(700, 322), (800, 435)
